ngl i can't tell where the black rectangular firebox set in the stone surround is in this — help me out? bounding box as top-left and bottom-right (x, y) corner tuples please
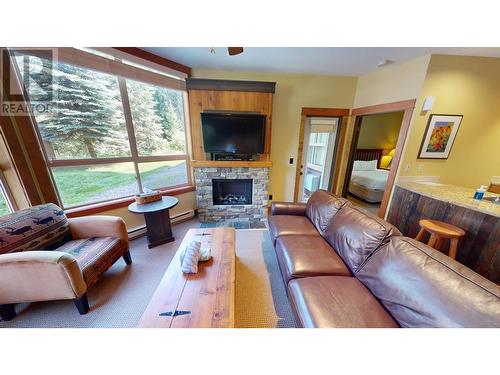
(212, 178), (253, 206)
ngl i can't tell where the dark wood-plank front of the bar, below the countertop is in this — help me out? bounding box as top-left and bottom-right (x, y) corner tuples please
(387, 186), (500, 284)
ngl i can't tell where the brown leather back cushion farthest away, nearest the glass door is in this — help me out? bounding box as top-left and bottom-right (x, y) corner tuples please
(306, 190), (348, 234)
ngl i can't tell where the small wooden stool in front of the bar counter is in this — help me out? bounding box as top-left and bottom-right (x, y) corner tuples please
(415, 219), (465, 259)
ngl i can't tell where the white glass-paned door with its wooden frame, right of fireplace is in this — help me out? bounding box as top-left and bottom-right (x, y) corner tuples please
(294, 108), (349, 202)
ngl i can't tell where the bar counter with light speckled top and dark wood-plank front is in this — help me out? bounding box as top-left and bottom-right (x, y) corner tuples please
(387, 182), (500, 284)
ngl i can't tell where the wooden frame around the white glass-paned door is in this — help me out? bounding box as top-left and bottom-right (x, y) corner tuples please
(293, 107), (350, 202)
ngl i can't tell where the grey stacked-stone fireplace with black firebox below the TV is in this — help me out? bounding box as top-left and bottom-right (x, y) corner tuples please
(194, 167), (269, 223)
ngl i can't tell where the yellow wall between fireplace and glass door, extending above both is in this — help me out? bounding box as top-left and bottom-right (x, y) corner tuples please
(189, 69), (357, 200)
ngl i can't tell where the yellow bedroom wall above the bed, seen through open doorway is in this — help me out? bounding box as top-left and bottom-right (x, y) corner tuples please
(357, 112), (404, 150)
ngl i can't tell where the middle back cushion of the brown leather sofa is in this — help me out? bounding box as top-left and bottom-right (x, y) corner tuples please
(324, 205), (401, 274)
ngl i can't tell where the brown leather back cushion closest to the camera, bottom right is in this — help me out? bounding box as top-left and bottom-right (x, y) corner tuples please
(356, 237), (500, 327)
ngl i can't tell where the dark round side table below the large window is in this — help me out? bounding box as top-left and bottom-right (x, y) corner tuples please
(128, 196), (179, 249)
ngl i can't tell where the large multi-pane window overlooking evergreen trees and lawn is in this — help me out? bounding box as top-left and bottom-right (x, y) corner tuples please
(14, 51), (190, 208)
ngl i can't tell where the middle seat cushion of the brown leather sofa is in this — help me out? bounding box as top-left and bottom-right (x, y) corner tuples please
(276, 236), (351, 283)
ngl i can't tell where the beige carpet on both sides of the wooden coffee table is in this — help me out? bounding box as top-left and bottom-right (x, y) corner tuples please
(0, 219), (294, 328)
